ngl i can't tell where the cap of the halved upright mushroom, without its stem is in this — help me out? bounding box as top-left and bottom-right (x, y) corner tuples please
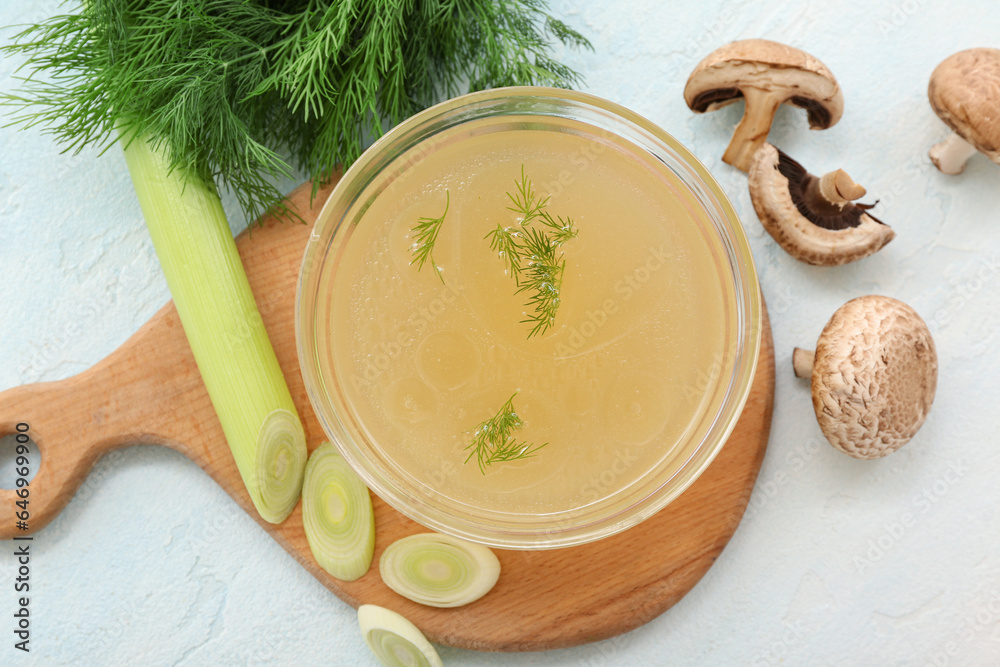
(684, 39), (844, 130)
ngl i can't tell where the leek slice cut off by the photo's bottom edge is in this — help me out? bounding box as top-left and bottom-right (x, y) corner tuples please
(358, 604), (442, 667)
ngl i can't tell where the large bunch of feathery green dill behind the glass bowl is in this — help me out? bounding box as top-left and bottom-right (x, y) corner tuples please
(0, 0), (590, 226)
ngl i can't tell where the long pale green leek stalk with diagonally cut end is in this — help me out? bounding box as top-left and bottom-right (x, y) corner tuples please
(121, 137), (308, 523)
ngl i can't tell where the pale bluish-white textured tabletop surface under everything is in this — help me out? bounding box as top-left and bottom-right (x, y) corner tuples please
(0, 0), (1000, 666)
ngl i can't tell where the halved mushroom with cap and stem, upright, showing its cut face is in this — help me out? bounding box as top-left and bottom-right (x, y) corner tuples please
(684, 39), (844, 171)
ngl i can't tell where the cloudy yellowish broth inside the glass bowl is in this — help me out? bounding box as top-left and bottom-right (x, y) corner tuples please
(319, 129), (735, 514)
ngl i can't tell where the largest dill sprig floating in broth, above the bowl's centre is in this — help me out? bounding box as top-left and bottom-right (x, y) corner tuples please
(486, 165), (579, 338)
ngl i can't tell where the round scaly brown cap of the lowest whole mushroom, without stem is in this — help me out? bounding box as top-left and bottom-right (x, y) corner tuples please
(812, 295), (937, 459)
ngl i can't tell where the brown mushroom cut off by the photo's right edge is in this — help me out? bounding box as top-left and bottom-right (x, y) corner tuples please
(927, 48), (1000, 174)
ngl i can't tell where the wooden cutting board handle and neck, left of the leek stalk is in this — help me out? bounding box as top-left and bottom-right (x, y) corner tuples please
(0, 303), (203, 540)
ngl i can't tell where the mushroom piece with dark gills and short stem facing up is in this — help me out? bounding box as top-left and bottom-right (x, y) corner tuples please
(749, 143), (896, 266)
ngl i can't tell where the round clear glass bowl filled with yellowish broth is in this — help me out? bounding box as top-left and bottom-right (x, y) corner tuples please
(296, 87), (761, 549)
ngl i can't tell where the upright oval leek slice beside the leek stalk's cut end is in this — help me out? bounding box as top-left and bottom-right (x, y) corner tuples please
(302, 442), (375, 581)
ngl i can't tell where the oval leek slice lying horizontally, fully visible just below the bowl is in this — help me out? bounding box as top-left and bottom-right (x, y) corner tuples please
(378, 533), (500, 607)
